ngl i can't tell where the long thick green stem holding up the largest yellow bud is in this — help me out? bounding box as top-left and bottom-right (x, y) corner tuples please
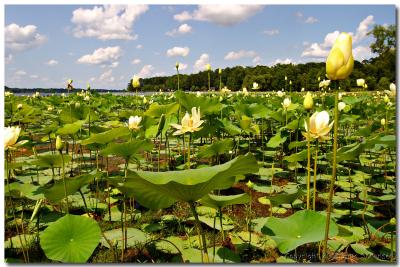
(322, 90), (339, 263)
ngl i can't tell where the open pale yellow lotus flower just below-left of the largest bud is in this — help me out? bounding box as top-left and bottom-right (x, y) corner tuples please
(303, 111), (333, 141)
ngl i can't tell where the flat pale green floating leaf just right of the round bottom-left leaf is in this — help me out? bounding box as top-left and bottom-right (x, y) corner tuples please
(101, 228), (149, 248)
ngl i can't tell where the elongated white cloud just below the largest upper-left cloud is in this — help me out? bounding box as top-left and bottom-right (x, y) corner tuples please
(76, 46), (122, 65)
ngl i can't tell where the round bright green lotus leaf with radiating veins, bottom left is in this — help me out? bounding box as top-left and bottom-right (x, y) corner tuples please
(40, 214), (101, 263)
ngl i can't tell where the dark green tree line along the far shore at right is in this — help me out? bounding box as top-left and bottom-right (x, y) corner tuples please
(126, 25), (396, 91)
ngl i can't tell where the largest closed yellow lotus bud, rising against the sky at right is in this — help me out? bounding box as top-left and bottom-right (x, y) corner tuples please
(326, 33), (354, 80)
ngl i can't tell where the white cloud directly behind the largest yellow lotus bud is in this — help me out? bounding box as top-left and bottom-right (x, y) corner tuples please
(301, 15), (374, 59)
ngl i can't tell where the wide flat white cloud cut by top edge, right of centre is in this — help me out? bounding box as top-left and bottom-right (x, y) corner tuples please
(174, 5), (263, 26)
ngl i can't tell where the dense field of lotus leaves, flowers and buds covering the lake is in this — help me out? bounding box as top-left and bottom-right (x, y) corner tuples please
(4, 34), (396, 263)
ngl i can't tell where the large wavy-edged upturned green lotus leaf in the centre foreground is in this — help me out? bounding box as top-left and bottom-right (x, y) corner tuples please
(109, 153), (258, 209)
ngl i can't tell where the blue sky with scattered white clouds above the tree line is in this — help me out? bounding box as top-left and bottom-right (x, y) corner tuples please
(4, 5), (396, 89)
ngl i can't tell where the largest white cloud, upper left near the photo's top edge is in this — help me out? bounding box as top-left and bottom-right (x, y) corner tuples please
(71, 5), (149, 40)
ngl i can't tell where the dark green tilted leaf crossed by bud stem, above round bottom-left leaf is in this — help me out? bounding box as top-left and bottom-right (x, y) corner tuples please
(44, 174), (96, 203)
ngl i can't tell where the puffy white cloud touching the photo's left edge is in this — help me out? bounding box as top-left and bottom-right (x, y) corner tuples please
(4, 23), (47, 51)
